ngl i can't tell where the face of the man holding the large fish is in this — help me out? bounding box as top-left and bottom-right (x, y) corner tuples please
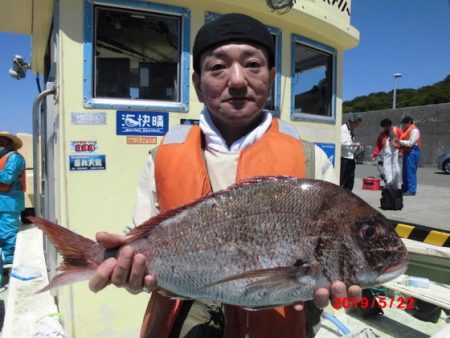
(192, 43), (275, 129)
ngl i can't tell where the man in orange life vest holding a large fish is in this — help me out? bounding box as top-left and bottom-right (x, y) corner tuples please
(89, 13), (361, 338)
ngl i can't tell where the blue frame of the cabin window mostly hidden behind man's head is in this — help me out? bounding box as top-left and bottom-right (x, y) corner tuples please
(205, 12), (282, 117)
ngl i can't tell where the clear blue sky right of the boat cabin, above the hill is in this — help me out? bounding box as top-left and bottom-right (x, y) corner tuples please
(343, 0), (450, 100)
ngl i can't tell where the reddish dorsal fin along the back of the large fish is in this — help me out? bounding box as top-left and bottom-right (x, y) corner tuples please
(127, 176), (293, 243)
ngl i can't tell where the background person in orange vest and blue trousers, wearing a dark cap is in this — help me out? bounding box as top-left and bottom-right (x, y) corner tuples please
(395, 116), (422, 196)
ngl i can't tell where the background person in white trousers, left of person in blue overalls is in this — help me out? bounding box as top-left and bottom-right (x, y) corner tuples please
(371, 119), (402, 189)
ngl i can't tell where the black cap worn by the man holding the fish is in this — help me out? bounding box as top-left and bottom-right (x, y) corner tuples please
(192, 13), (275, 73)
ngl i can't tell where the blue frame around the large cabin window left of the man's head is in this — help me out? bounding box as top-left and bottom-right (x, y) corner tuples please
(83, 0), (191, 112)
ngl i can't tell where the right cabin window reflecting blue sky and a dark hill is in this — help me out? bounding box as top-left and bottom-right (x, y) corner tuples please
(291, 35), (336, 123)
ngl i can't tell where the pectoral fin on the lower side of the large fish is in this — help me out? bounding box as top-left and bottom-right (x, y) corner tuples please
(204, 265), (310, 290)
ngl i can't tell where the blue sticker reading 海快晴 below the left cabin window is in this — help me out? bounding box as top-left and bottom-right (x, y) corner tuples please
(116, 111), (169, 136)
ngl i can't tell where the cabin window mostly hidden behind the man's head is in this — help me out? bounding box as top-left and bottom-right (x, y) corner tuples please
(205, 12), (281, 117)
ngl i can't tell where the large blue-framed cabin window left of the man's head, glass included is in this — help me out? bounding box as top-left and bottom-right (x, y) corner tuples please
(85, 1), (189, 111)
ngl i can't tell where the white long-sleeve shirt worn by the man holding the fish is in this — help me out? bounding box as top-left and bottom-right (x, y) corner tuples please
(125, 112), (337, 232)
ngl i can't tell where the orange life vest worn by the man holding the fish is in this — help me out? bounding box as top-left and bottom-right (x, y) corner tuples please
(141, 119), (306, 338)
